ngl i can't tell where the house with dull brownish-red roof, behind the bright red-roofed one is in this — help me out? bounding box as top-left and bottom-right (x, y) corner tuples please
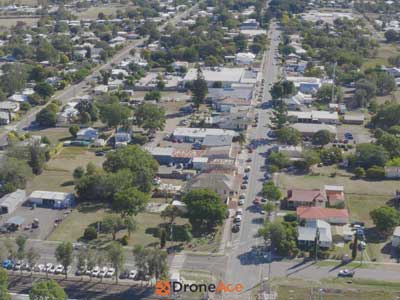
(286, 189), (326, 209)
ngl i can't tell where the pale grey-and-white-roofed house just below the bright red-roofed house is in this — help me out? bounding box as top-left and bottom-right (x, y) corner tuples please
(297, 220), (332, 249)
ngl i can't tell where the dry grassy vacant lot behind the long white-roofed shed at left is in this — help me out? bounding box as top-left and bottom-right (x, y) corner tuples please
(27, 147), (104, 192)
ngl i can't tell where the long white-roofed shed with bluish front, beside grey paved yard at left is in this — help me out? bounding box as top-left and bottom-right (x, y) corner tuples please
(29, 191), (74, 208)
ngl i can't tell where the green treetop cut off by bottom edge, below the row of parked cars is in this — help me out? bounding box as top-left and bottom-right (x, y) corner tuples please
(29, 280), (67, 300)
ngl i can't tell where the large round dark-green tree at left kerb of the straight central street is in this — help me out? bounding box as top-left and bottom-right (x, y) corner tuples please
(182, 189), (227, 229)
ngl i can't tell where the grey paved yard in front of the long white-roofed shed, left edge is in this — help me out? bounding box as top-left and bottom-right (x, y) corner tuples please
(0, 205), (69, 240)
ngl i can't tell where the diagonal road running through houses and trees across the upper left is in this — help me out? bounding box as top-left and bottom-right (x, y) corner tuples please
(0, 3), (199, 146)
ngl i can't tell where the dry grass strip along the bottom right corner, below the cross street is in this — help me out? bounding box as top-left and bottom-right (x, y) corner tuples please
(273, 278), (400, 300)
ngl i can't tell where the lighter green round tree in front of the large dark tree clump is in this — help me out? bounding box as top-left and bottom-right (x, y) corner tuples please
(112, 187), (149, 217)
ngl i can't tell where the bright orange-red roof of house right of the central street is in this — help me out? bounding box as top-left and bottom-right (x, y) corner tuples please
(296, 206), (349, 225)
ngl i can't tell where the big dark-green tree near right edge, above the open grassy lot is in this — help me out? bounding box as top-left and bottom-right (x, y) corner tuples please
(356, 143), (389, 169)
